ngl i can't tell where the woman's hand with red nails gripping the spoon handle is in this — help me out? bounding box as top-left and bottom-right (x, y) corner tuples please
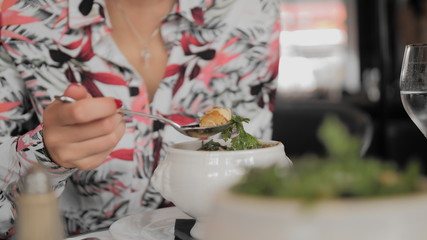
(43, 84), (125, 170)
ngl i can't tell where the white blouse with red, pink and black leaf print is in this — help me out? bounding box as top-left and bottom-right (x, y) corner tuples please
(0, 0), (280, 236)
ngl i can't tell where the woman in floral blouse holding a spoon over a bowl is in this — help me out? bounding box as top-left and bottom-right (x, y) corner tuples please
(0, 0), (280, 238)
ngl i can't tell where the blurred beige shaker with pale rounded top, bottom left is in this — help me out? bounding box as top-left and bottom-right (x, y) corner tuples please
(16, 167), (64, 240)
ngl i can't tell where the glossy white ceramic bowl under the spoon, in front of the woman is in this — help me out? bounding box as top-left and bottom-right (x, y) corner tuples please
(151, 141), (292, 239)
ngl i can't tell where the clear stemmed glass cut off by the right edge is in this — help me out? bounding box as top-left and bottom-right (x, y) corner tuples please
(400, 43), (427, 137)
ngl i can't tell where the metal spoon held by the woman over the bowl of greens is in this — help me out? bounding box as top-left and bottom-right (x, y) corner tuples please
(55, 96), (231, 138)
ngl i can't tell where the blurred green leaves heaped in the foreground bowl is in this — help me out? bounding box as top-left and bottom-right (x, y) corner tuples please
(233, 116), (422, 202)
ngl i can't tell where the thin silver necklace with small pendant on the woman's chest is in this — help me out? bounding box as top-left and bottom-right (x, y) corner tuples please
(114, 0), (160, 68)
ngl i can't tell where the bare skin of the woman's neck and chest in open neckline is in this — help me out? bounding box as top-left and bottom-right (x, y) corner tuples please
(107, 0), (175, 101)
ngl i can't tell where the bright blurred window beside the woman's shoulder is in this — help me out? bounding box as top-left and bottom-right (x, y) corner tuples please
(278, 0), (362, 101)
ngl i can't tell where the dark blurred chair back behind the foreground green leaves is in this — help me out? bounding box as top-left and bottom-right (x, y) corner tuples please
(273, 100), (373, 159)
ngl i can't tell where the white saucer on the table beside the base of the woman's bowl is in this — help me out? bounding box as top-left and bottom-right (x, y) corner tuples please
(110, 207), (192, 240)
